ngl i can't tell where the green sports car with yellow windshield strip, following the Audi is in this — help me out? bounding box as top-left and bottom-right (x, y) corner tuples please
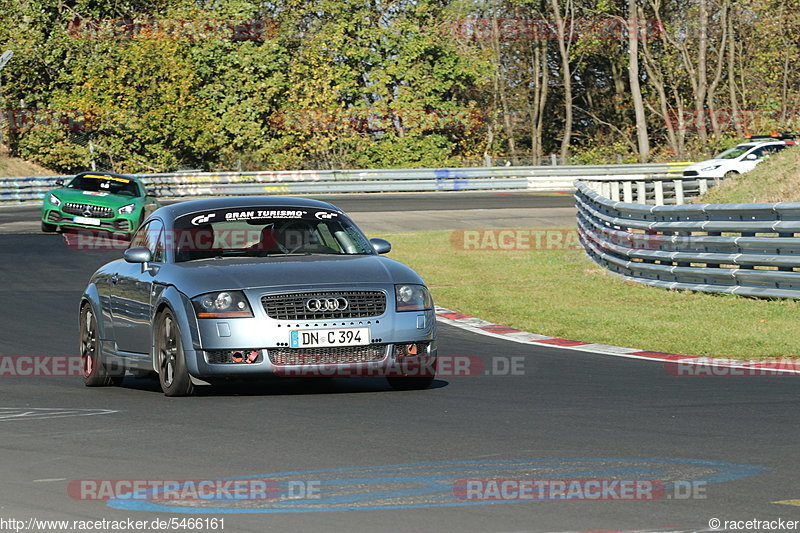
(42, 172), (160, 235)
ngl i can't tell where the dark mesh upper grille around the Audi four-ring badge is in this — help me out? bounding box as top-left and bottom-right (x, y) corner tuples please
(261, 291), (386, 320)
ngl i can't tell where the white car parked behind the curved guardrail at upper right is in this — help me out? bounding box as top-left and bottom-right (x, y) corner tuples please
(683, 133), (798, 178)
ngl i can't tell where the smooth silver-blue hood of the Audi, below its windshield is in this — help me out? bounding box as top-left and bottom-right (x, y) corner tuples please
(158, 255), (423, 297)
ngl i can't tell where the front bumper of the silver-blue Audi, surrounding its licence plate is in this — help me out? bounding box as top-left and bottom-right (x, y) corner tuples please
(185, 311), (437, 381)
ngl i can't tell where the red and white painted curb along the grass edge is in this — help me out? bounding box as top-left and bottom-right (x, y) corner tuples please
(436, 307), (800, 375)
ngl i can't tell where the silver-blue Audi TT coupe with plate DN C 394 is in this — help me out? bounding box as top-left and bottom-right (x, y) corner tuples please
(80, 197), (436, 396)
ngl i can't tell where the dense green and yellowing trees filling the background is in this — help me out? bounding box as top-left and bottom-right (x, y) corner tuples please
(0, 0), (800, 172)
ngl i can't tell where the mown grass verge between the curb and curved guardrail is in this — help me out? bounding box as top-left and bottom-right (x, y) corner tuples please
(380, 228), (800, 359)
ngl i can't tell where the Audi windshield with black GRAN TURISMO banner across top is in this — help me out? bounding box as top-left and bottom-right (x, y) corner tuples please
(173, 206), (375, 263)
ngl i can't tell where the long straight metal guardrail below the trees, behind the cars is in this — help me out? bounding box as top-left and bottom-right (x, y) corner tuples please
(0, 163), (688, 205)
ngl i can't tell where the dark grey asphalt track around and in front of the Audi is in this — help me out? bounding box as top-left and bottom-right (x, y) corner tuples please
(0, 191), (800, 532)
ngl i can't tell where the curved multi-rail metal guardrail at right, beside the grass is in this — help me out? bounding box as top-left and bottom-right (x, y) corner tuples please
(575, 182), (800, 298)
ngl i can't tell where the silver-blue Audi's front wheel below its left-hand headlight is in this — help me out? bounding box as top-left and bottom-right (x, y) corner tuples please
(155, 309), (194, 396)
